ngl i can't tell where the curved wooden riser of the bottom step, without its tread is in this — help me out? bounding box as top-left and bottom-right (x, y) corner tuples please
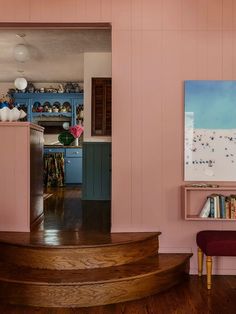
(0, 259), (189, 307)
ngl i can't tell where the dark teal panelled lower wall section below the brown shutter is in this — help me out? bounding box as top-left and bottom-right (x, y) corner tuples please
(82, 142), (111, 200)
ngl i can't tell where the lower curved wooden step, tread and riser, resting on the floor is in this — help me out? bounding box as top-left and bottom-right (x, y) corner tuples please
(0, 254), (191, 307)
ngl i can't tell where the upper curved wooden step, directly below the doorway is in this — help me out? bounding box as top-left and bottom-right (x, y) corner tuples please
(0, 231), (160, 270)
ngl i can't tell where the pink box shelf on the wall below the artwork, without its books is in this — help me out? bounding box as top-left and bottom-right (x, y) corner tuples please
(181, 185), (236, 221)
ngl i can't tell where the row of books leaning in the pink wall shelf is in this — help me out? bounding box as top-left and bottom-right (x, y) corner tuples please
(199, 194), (236, 219)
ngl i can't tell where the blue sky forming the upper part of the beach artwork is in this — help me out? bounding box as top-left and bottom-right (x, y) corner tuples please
(185, 81), (236, 129)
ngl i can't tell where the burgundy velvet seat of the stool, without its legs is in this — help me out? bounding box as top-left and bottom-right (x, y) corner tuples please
(197, 230), (236, 256)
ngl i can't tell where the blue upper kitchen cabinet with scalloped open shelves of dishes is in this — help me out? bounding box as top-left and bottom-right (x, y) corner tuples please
(13, 93), (84, 125)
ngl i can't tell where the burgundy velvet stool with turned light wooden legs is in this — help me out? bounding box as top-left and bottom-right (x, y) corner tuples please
(196, 230), (236, 289)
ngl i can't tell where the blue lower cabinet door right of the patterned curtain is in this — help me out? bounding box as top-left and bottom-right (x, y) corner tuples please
(65, 157), (82, 184)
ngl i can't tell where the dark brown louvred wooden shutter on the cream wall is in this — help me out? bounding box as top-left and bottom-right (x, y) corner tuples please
(92, 77), (111, 136)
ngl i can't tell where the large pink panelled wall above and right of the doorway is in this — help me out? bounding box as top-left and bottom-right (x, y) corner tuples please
(0, 0), (236, 273)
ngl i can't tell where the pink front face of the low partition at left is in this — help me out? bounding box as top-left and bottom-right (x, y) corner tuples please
(0, 122), (30, 232)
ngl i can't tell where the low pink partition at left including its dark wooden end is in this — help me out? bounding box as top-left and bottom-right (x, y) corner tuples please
(0, 121), (43, 232)
